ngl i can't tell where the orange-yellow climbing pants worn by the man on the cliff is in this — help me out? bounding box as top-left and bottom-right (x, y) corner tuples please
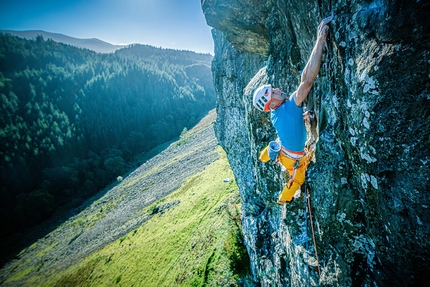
(260, 146), (307, 202)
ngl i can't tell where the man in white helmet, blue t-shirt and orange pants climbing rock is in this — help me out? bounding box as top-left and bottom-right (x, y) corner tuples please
(253, 15), (333, 205)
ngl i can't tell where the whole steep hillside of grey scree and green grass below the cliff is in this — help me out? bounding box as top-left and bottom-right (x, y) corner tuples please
(0, 109), (250, 286)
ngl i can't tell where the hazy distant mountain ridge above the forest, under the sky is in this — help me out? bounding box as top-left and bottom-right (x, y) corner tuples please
(0, 30), (127, 53)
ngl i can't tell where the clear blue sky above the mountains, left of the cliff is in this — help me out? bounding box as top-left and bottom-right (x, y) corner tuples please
(0, 0), (213, 54)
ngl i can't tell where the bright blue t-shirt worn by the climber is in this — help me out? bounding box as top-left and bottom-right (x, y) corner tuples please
(270, 92), (306, 152)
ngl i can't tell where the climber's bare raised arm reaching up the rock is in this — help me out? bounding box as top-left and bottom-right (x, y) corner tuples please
(294, 16), (333, 107)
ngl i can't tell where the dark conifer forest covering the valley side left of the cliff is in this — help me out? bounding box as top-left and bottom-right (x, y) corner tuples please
(0, 34), (215, 236)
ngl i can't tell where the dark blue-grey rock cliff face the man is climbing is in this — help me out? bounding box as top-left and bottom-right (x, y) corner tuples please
(202, 0), (430, 286)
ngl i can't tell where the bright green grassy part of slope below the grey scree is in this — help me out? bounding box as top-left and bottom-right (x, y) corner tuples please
(42, 150), (249, 286)
